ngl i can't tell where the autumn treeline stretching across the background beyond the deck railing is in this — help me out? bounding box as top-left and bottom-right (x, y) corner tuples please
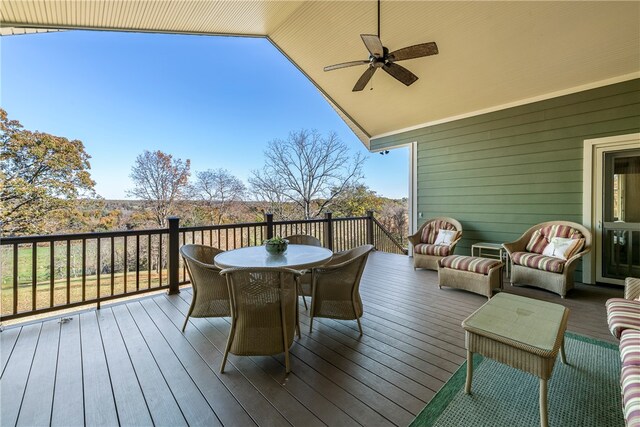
(0, 109), (407, 244)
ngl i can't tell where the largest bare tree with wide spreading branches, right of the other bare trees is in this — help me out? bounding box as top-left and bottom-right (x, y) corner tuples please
(249, 130), (365, 219)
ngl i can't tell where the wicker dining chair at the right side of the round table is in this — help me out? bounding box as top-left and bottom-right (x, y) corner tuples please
(309, 245), (373, 335)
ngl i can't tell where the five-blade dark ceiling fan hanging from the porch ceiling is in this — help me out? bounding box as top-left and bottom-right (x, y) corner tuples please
(324, 0), (438, 92)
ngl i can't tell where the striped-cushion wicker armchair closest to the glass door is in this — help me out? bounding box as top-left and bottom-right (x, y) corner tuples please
(503, 221), (591, 298)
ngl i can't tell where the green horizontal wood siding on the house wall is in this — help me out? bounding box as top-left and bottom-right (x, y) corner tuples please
(371, 79), (640, 280)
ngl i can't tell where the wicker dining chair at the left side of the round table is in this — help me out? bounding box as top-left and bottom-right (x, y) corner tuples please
(180, 245), (231, 332)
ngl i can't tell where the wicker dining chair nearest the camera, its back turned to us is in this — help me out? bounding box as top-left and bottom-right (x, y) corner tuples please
(220, 268), (300, 373)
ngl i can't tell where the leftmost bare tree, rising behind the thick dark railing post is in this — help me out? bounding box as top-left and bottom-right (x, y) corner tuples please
(127, 150), (191, 228)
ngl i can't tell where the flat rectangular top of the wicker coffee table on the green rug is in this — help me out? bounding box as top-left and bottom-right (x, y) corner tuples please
(462, 292), (566, 351)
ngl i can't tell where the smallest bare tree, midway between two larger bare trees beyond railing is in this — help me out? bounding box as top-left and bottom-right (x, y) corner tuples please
(192, 169), (246, 224)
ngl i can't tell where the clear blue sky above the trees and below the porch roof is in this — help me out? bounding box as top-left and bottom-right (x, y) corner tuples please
(0, 31), (408, 199)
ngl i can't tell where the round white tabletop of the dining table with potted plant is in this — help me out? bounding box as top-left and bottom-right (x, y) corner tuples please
(214, 245), (333, 269)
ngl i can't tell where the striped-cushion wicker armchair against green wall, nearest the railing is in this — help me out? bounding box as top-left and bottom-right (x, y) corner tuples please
(409, 217), (462, 270)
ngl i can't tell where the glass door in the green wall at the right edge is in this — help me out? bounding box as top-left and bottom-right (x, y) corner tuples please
(598, 150), (640, 283)
